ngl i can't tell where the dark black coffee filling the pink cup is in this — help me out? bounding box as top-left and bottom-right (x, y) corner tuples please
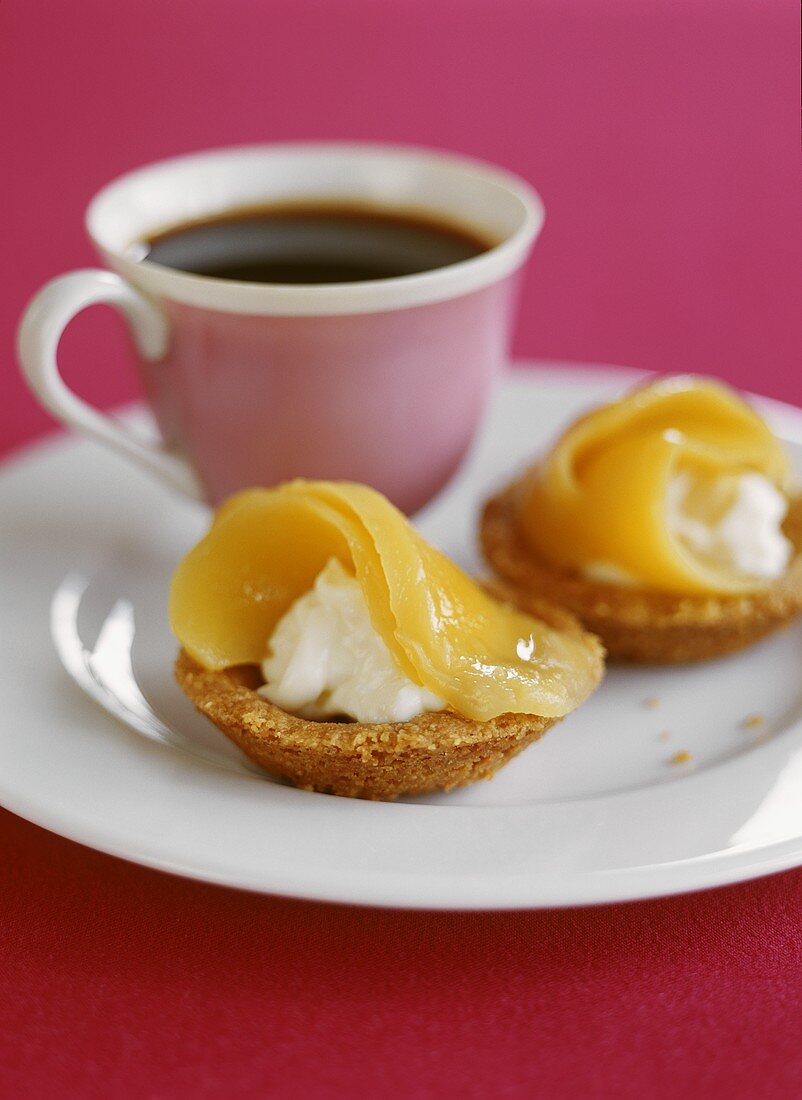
(131, 206), (494, 284)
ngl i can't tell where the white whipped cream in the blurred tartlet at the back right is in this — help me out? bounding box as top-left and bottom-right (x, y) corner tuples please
(667, 473), (793, 581)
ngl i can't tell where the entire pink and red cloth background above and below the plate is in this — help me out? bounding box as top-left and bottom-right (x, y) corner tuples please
(0, 0), (802, 1098)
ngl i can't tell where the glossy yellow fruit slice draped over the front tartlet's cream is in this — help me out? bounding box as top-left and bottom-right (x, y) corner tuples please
(169, 481), (602, 721)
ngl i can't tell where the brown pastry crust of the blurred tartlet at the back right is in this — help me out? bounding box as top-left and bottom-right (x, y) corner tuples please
(480, 482), (802, 664)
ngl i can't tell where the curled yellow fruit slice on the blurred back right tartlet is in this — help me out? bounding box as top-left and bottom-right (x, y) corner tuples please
(520, 375), (791, 594)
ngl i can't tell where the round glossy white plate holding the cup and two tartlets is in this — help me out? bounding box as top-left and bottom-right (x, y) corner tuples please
(0, 364), (802, 909)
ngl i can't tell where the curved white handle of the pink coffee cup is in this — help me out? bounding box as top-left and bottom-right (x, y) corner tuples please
(17, 270), (204, 501)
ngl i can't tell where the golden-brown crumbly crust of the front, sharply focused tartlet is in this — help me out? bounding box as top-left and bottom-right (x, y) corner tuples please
(175, 587), (603, 800)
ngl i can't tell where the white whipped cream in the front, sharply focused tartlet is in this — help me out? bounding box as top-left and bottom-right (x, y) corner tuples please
(259, 558), (446, 722)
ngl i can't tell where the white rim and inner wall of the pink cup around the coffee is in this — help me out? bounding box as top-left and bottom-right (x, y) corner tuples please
(86, 142), (545, 316)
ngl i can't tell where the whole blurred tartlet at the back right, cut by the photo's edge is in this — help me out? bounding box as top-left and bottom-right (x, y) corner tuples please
(481, 376), (802, 663)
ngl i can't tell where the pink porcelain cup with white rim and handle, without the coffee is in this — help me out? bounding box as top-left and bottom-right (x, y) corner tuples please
(19, 143), (543, 512)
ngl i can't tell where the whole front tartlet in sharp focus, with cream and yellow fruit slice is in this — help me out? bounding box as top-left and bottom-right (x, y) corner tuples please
(169, 481), (604, 799)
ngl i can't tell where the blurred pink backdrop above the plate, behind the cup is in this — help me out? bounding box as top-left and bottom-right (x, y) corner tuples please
(0, 0), (802, 455)
